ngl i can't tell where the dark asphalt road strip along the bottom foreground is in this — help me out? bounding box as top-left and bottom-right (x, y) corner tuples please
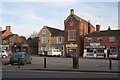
(2, 71), (118, 78)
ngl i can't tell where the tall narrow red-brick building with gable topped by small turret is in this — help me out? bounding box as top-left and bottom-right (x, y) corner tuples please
(64, 9), (95, 56)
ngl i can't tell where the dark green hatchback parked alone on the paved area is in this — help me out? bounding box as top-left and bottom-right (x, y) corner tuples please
(9, 52), (32, 65)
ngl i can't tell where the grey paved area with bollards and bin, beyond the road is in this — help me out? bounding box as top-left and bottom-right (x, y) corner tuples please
(2, 56), (120, 73)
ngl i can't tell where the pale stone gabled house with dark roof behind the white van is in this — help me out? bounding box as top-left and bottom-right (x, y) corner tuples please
(38, 26), (64, 55)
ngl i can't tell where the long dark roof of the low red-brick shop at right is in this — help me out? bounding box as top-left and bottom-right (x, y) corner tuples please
(85, 30), (120, 37)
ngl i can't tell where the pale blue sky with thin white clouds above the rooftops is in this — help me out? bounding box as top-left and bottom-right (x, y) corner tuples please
(0, 0), (118, 37)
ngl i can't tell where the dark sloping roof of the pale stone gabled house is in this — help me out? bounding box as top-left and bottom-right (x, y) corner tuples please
(45, 26), (64, 37)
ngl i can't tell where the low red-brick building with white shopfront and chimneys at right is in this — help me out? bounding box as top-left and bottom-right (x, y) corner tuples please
(83, 25), (120, 58)
